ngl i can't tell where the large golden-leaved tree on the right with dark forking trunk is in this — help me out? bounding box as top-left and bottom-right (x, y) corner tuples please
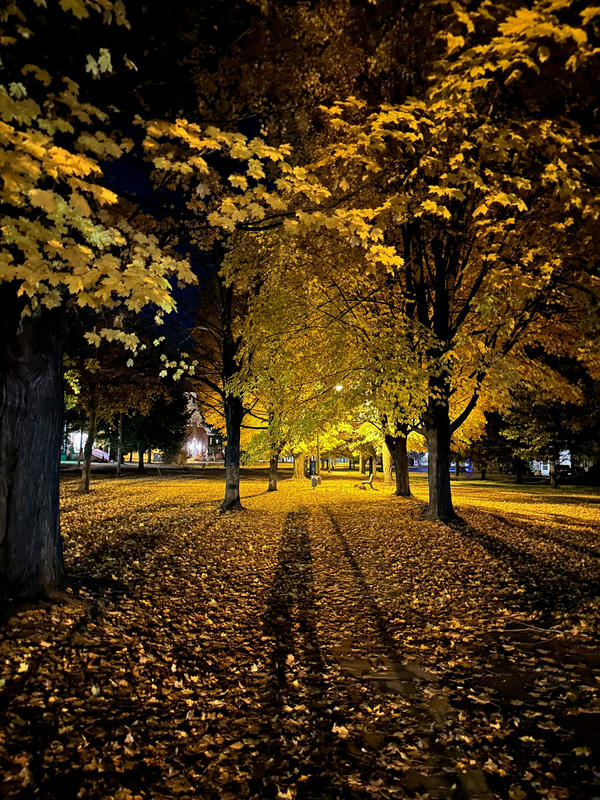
(270, 1), (598, 520)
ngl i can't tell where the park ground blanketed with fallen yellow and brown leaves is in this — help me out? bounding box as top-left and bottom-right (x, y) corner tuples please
(0, 470), (600, 800)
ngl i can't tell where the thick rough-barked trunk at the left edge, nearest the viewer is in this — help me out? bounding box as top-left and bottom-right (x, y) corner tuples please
(0, 302), (64, 598)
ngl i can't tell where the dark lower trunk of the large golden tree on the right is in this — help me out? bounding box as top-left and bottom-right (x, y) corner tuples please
(425, 397), (456, 522)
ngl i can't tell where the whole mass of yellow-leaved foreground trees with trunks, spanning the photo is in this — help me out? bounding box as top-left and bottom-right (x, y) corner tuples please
(0, 0), (599, 595)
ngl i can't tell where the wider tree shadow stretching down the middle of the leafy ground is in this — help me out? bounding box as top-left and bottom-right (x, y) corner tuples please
(251, 509), (338, 798)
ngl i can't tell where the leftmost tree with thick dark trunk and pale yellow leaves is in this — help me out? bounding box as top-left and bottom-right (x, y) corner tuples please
(0, 0), (191, 597)
